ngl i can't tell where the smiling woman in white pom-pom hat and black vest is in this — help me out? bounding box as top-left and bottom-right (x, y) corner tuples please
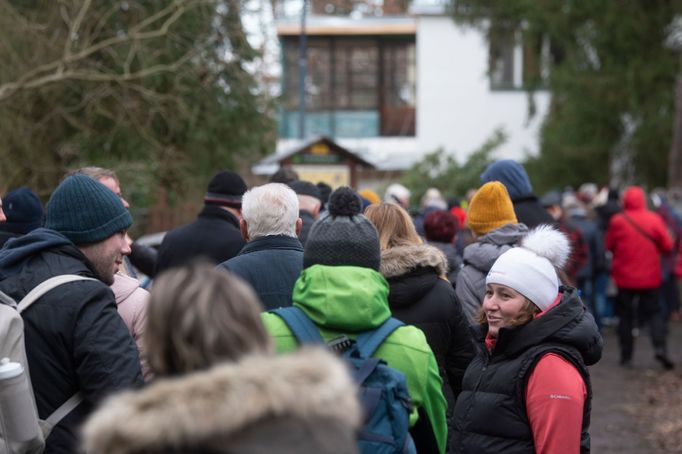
(454, 225), (602, 453)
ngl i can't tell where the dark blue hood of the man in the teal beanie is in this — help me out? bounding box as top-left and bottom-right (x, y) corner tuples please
(0, 228), (75, 280)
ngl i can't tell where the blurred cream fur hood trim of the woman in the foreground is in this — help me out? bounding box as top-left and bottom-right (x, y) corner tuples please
(83, 348), (361, 454)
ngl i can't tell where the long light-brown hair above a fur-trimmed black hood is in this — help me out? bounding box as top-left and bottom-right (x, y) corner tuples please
(365, 202), (422, 251)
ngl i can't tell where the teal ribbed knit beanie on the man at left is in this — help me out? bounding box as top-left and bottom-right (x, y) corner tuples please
(45, 174), (133, 244)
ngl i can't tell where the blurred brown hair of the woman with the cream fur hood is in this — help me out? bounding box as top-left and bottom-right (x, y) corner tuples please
(144, 262), (272, 375)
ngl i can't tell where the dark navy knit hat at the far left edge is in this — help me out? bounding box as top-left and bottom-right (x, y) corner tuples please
(0, 188), (43, 235)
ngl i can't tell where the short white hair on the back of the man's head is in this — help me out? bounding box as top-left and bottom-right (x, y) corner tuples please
(242, 183), (298, 240)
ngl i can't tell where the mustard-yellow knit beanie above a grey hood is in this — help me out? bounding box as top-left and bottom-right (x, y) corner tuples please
(466, 181), (518, 236)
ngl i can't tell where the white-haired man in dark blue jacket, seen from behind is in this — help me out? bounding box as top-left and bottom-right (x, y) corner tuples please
(221, 183), (303, 310)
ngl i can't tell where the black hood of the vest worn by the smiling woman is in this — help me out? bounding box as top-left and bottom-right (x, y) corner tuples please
(486, 287), (603, 366)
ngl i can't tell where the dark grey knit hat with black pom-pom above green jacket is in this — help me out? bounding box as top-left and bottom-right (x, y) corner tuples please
(303, 187), (381, 270)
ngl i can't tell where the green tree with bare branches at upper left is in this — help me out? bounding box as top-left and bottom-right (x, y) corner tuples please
(0, 0), (274, 199)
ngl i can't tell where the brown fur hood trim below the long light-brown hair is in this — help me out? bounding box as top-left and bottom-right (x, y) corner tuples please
(380, 244), (448, 279)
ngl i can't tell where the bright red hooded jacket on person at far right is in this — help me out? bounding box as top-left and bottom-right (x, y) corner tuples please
(606, 186), (673, 289)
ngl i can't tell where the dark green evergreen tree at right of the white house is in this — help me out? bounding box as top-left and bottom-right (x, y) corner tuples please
(453, 0), (682, 192)
